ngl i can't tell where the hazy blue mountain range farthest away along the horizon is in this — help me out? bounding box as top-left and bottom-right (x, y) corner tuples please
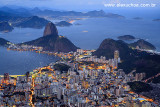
(0, 6), (125, 18)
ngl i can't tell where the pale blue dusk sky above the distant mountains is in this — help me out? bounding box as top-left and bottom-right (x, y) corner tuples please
(0, 0), (160, 10)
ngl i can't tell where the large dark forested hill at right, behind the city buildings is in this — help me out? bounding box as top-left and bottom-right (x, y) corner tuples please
(93, 39), (160, 82)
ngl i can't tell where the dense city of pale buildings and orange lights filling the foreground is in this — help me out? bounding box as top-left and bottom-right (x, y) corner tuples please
(0, 49), (156, 107)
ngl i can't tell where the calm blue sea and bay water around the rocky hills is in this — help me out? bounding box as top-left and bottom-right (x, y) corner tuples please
(0, 18), (160, 75)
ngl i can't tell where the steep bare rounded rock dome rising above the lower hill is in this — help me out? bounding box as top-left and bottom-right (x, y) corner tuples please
(43, 22), (58, 37)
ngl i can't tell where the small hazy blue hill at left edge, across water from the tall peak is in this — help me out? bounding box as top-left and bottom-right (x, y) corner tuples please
(0, 21), (14, 33)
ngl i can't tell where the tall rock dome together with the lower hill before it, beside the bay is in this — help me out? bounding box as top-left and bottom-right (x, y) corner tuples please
(23, 22), (77, 52)
